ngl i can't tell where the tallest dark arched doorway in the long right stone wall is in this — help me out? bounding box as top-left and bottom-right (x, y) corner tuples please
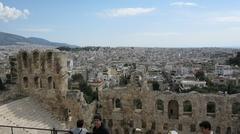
(168, 100), (179, 119)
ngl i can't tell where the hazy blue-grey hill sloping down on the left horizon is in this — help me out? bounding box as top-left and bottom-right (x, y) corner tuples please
(0, 32), (76, 47)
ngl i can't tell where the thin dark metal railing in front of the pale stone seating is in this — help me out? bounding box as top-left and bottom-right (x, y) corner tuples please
(0, 125), (70, 134)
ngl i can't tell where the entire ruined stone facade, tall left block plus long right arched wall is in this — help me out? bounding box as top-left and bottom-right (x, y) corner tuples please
(12, 50), (240, 134)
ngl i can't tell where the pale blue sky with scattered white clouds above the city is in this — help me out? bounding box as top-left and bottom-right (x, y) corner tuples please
(0, 0), (240, 47)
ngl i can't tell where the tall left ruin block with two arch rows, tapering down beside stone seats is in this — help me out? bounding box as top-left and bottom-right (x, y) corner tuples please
(16, 50), (68, 118)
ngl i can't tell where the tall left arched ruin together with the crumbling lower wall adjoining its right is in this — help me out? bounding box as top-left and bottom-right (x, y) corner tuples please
(16, 50), (96, 127)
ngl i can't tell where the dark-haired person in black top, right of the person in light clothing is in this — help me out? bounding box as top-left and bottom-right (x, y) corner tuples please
(93, 114), (109, 134)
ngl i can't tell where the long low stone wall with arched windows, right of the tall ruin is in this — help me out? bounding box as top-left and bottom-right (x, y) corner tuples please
(100, 88), (240, 134)
